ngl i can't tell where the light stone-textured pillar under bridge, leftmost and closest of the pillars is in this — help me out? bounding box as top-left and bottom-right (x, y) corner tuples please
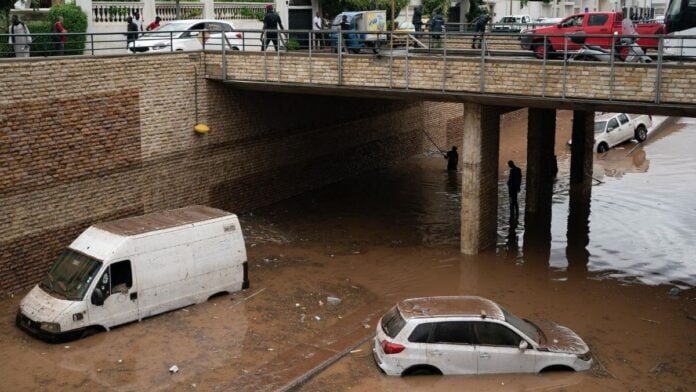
(460, 103), (500, 255)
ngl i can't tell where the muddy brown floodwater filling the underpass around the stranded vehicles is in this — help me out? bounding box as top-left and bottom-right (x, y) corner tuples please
(0, 112), (696, 391)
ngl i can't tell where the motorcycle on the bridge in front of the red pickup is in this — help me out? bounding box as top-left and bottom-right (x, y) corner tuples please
(568, 33), (652, 63)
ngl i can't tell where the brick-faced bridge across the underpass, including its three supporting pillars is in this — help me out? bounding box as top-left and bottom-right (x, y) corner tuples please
(206, 52), (696, 254)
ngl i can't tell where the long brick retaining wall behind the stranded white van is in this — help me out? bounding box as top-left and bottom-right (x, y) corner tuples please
(0, 54), (461, 293)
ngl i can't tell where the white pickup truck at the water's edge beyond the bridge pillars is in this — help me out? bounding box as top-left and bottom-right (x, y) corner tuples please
(594, 113), (652, 152)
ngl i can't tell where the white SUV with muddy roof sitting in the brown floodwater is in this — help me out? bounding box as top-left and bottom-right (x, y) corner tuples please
(372, 296), (592, 376)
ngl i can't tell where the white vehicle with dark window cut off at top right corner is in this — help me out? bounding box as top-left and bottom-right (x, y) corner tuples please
(664, 0), (696, 57)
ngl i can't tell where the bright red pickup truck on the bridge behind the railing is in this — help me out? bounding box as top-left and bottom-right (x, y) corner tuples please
(520, 12), (665, 59)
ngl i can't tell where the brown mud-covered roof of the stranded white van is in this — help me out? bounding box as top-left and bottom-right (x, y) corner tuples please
(93, 206), (233, 236)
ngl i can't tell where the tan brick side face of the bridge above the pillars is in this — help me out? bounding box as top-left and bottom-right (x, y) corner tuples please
(220, 52), (696, 104)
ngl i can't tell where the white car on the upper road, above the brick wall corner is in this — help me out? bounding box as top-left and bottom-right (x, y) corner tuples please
(128, 19), (243, 53)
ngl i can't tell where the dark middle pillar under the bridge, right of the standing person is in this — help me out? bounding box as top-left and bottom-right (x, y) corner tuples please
(524, 108), (556, 258)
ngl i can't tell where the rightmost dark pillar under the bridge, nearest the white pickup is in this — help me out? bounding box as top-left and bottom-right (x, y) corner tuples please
(566, 111), (594, 279)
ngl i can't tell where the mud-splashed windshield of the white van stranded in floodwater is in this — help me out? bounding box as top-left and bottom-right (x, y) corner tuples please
(39, 249), (102, 301)
